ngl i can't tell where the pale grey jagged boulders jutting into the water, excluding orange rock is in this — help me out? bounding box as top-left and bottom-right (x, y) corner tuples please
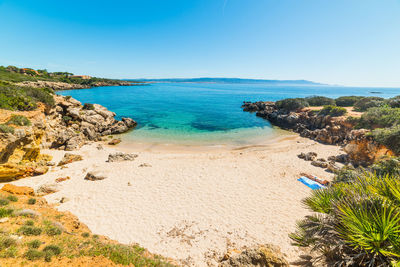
(43, 96), (136, 151)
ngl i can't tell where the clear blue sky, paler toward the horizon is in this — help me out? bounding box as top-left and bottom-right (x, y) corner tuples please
(0, 0), (400, 87)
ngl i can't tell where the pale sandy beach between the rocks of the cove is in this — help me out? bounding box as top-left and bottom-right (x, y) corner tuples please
(9, 136), (340, 266)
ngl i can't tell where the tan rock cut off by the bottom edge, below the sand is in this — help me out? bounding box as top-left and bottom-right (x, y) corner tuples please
(219, 245), (289, 267)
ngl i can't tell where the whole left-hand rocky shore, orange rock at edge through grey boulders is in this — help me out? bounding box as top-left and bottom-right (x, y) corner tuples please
(0, 95), (137, 181)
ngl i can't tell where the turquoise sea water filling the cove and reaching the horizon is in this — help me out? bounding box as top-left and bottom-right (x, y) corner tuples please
(58, 83), (400, 145)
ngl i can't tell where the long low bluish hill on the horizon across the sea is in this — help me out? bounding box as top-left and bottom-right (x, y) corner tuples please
(136, 78), (321, 85)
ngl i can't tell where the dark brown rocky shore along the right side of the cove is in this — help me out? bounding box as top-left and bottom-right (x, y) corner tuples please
(242, 101), (394, 166)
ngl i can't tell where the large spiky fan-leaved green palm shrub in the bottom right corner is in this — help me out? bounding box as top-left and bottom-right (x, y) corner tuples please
(290, 171), (400, 266)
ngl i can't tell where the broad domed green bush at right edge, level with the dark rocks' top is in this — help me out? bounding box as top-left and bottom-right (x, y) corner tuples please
(357, 107), (400, 129)
